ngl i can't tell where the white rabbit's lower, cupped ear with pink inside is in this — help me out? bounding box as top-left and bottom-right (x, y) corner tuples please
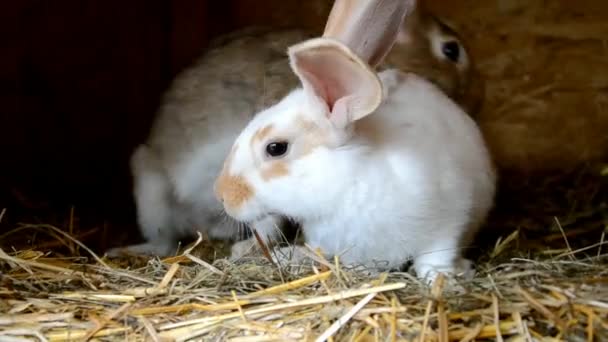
(288, 38), (382, 128)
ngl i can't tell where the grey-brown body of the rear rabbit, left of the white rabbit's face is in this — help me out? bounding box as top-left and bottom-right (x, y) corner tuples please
(107, 28), (309, 256)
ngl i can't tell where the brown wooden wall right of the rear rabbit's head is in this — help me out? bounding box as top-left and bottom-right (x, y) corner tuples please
(432, 0), (608, 172)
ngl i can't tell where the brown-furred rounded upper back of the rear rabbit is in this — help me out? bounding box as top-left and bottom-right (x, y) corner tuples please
(148, 27), (308, 160)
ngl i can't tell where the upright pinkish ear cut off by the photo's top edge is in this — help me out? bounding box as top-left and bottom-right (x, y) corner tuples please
(323, 0), (420, 68)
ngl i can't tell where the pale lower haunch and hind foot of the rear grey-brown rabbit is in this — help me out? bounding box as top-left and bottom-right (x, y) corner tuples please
(108, 139), (237, 256)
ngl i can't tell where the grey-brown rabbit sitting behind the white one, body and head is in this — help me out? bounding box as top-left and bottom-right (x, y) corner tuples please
(108, 1), (483, 257)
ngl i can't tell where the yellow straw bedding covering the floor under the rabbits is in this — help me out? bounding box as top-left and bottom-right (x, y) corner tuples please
(0, 219), (608, 341)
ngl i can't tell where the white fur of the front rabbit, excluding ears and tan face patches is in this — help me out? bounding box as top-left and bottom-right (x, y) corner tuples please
(222, 70), (495, 280)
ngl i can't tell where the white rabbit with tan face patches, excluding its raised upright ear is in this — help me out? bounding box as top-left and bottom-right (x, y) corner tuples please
(215, 1), (496, 280)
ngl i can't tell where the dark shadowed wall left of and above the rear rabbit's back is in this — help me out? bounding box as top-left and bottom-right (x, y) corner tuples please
(0, 0), (330, 228)
